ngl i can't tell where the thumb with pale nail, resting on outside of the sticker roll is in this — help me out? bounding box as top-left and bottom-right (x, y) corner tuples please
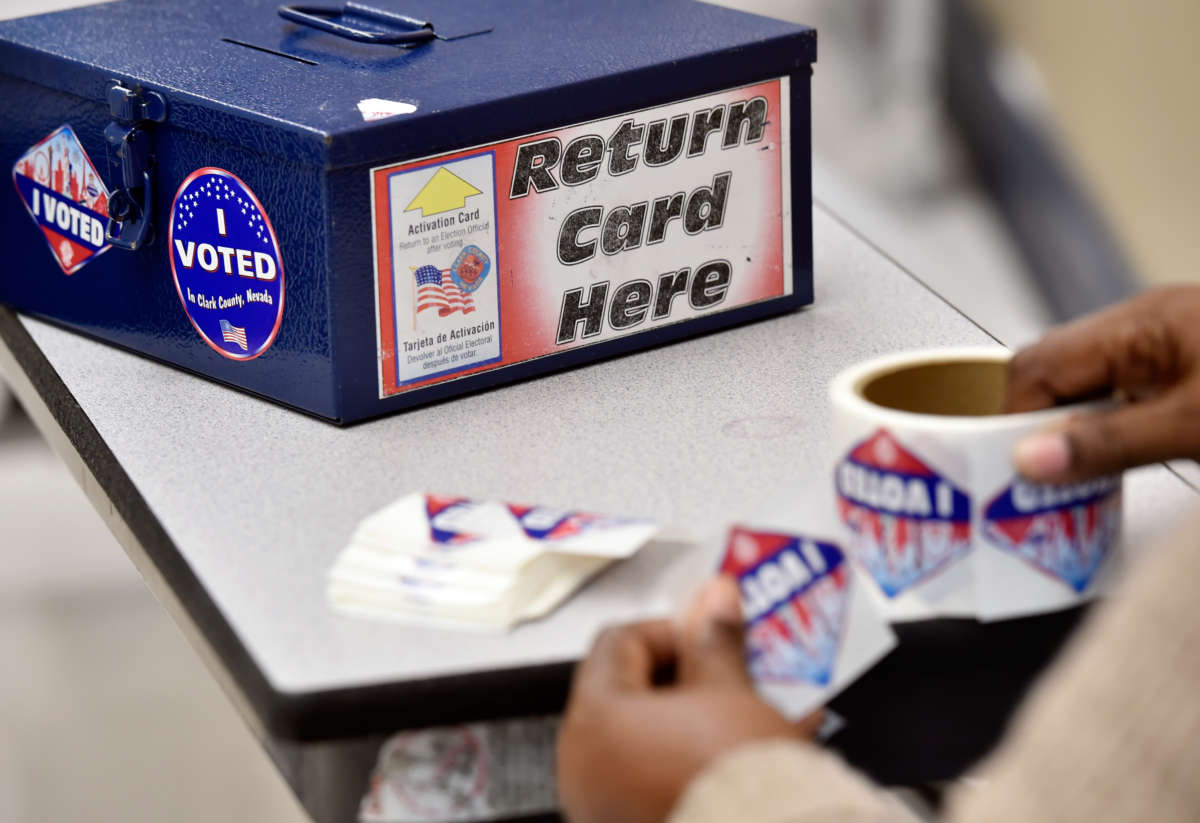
(1013, 391), (1200, 483)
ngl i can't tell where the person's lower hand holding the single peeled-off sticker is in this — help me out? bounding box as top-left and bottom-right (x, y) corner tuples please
(557, 577), (818, 823)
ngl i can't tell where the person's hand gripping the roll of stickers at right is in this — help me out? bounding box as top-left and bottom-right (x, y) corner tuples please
(1006, 286), (1200, 483)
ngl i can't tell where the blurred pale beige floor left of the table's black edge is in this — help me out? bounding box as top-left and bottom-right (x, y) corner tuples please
(0, 405), (305, 823)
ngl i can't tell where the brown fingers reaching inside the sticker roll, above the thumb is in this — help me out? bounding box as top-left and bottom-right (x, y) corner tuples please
(1004, 289), (1185, 413)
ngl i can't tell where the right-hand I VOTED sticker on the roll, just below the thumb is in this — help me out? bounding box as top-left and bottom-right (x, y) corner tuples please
(983, 477), (1121, 593)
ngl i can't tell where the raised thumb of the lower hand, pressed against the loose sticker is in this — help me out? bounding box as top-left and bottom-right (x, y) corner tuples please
(678, 576), (750, 686)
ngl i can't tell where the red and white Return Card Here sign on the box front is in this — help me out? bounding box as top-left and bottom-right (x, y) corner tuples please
(370, 78), (792, 397)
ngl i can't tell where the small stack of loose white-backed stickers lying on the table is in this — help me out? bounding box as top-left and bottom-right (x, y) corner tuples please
(328, 494), (658, 630)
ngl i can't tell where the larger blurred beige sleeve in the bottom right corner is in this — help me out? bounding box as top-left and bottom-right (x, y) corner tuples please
(948, 513), (1200, 823)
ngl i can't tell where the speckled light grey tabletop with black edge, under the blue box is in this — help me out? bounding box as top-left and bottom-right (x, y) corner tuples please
(0, 201), (1195, 819)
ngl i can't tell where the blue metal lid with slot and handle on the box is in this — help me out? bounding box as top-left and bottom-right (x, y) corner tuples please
(0, 0), (816, 167)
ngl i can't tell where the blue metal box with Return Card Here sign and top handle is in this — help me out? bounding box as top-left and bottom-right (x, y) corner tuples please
(0, 0), (816, 422)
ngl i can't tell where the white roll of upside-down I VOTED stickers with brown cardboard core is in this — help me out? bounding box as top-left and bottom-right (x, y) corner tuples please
(830, 347), (1121, 620)
